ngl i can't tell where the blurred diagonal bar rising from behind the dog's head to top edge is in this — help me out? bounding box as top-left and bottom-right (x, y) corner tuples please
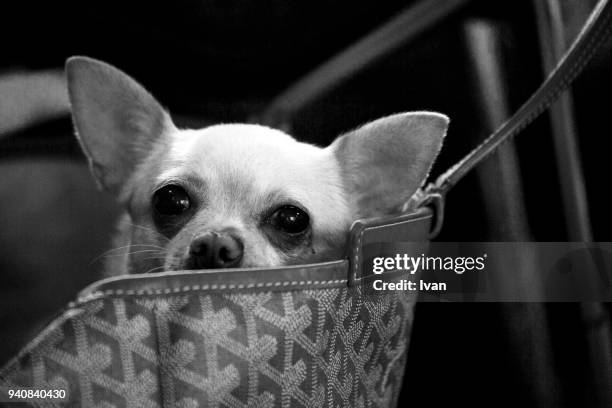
(258, 0), (470, 129)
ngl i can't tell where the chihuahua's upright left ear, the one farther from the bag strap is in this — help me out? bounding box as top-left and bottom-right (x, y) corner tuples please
(66, 57), (174, 193)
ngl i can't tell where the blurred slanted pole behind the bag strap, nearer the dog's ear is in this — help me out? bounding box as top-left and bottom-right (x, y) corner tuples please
(465, 20), (559, 407)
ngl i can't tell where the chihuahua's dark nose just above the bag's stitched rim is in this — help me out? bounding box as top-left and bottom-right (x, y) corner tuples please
(189, 232), (244, 269)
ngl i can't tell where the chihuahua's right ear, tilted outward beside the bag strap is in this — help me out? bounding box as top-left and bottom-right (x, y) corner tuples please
(329, 112), (449, 218)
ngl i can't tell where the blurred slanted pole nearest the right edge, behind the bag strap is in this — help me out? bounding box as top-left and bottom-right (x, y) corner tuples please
(533, 0), (612, 407)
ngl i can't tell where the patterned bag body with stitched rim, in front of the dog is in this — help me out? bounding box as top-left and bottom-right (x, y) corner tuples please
(0, 209), (429, 408)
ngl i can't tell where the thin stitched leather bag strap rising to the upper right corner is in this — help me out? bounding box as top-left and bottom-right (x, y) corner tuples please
(418, 0), (612, 203)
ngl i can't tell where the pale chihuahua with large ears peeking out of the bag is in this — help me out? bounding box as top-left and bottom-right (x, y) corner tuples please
(66, 57), (448, 275)
